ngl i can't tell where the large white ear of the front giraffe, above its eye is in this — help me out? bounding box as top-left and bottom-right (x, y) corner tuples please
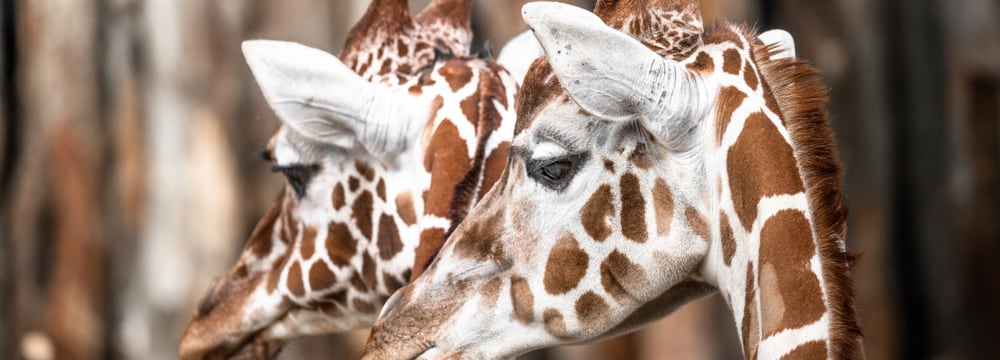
(521, 2), (710, 146)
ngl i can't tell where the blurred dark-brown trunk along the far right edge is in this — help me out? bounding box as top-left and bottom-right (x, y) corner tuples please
(936, 0), (1000, 359)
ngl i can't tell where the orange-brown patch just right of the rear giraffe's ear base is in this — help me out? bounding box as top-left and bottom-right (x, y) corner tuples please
(424, 120), (471, 219)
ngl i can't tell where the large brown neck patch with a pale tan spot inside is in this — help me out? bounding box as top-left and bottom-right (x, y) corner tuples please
(760, 210), (826, 338)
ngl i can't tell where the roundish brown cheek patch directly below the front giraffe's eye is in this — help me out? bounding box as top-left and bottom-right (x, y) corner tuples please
(542, 232), (590, 295)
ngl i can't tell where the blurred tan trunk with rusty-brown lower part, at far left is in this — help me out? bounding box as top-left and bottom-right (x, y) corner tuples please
(7, 0), (106, 359)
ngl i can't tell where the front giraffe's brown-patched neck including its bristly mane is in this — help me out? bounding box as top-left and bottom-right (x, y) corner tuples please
(704, 25), (860, 359)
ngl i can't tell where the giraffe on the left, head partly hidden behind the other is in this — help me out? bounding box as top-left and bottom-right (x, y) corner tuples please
(180, 0), (537, 359)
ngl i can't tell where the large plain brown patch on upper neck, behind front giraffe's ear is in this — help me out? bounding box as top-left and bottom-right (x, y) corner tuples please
(726, 112), (805, 232)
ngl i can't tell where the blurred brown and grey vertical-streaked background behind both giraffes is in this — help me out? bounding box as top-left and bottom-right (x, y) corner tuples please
(0, 0), (1000, 359)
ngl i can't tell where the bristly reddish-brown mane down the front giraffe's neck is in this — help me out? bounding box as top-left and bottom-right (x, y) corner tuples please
(744, 23), (864, 359)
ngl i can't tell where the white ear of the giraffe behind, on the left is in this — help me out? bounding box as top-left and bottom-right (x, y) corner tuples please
(243, 40), (427, 156)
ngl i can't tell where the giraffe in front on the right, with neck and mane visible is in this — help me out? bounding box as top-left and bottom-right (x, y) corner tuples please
(364, 0), (863, 359)
